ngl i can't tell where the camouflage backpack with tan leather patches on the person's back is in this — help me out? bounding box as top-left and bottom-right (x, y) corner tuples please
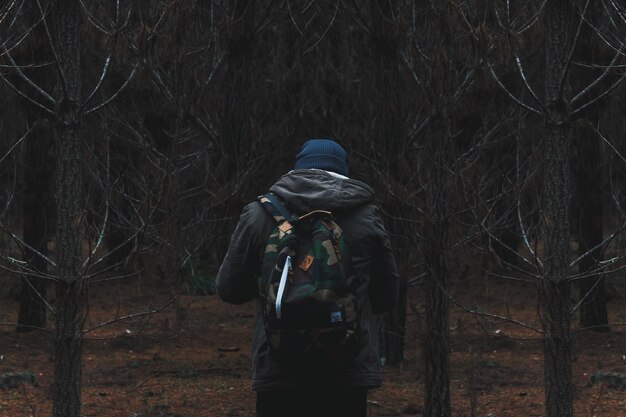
(258, 193), (358, 364)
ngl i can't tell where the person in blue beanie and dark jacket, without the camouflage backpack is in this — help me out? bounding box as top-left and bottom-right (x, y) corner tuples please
(217, 140), (398, 417)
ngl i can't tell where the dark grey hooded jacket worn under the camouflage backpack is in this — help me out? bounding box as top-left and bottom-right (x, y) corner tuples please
(217, 169), (399, 391)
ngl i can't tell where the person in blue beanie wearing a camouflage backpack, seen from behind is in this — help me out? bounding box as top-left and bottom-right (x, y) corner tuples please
(217, 139), (399, 417)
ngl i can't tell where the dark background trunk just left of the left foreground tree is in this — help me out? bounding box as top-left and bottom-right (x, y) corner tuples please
(17, 121), (51, 332)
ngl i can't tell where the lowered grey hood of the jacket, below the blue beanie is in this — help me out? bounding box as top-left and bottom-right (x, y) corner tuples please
(270, 169), (374, 214)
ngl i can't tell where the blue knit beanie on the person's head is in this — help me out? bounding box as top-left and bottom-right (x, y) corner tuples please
(295, 139), (348, 177)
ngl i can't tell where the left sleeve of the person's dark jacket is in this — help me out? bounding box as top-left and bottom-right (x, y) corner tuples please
(216, 202), (271, 304)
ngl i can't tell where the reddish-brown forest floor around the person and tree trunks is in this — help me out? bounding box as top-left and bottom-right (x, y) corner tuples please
(0, 270), (626, 417)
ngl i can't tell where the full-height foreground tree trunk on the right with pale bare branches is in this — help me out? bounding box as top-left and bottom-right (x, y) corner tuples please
(539, 0), (573, 417)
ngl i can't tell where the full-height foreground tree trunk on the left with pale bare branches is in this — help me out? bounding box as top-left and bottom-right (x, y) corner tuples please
(52, 0), (87, 417)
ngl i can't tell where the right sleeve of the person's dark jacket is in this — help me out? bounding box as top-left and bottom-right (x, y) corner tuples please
(369, 206), (400, 313)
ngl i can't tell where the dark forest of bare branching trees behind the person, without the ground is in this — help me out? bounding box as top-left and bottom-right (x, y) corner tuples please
(0, 0), (626, 417)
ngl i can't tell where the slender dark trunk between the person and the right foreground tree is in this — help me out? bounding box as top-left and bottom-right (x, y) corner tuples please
(421, 3), (450, 417)
